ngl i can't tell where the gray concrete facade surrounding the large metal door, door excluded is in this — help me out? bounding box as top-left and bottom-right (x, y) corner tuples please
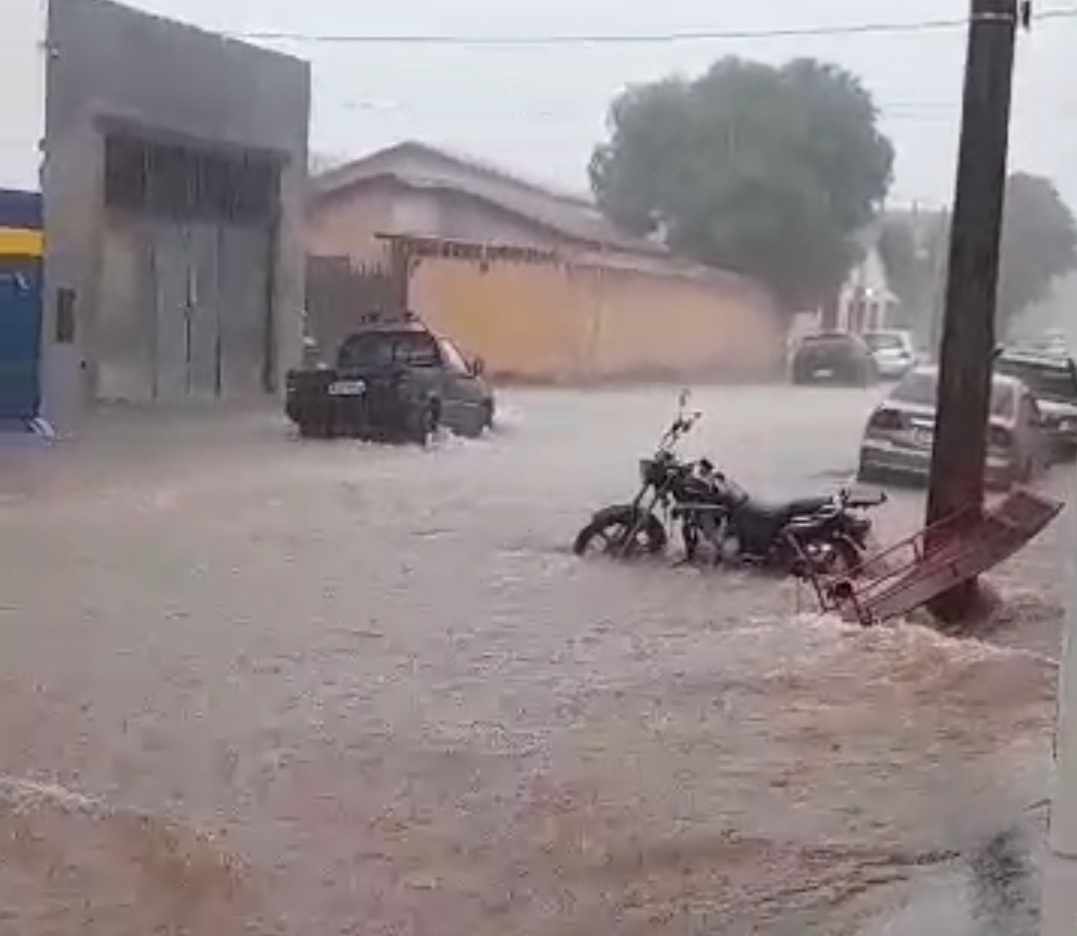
(42, 0), (310, 429)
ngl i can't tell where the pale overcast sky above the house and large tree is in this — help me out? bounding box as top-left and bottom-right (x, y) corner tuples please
(6, 0), (1077, 207)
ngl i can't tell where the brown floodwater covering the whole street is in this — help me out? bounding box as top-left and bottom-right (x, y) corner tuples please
(0, 387), (1073, 936)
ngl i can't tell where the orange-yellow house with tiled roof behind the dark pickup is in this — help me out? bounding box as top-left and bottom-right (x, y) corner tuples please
(307, 142), (782, 380)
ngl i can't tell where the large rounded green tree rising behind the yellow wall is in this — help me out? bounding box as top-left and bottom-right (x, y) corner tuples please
(590, 58), (894, 310)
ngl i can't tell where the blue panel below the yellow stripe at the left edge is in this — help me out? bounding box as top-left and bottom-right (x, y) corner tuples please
(0, 268), (41, 419)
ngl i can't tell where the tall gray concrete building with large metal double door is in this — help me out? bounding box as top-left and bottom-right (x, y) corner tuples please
(42, 0), (310, 430)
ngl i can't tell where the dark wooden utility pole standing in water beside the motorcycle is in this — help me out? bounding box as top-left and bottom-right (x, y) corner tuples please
(927, 0), (1025, 620)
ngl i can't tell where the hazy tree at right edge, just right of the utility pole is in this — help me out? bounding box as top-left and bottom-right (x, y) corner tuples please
(997, 172), (1077, 337)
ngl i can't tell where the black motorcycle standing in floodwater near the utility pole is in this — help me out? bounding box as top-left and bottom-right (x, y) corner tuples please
(573, 393), (886, 577)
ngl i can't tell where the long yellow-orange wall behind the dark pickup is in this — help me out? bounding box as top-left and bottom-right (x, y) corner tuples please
(409, 257), (784, 381)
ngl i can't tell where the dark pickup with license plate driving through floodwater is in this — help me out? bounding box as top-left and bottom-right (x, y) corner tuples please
(285, 317), (494, 444)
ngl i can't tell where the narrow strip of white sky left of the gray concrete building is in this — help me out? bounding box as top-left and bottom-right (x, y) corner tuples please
(0, 0), (46, 191)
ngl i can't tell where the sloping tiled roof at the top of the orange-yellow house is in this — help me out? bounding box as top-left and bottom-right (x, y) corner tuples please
(311, 142), (668, 256)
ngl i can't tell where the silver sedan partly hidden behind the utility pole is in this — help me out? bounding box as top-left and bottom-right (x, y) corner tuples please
(859, 367), (1051, 487)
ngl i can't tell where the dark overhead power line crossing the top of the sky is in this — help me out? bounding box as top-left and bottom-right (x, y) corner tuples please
(229, 6), (1077, 46)
